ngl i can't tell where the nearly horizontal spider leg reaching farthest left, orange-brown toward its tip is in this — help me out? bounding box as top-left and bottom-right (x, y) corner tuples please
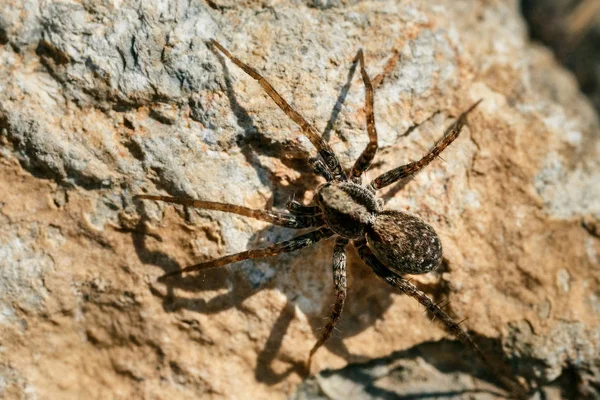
(133, 194), (323, 229)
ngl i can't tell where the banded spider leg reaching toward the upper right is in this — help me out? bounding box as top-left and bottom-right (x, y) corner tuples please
(371, 100), (482, 189)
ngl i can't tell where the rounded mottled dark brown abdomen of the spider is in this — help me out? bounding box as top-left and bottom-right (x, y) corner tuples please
(366, 210), (442, 275)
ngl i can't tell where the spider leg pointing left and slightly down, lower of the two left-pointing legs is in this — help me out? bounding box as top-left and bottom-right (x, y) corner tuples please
(159, 228), (333, 280)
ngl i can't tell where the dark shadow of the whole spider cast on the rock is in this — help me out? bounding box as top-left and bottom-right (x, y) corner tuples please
(131, 45), (500, 392)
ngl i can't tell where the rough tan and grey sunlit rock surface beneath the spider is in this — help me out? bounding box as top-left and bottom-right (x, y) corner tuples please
(0, 0), (600, 399)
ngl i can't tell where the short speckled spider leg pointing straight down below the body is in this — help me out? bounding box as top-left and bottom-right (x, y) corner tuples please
(307, 237), (348, 369)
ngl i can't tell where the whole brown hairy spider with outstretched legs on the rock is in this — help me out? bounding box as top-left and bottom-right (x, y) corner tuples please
(134, 40), (523, 394)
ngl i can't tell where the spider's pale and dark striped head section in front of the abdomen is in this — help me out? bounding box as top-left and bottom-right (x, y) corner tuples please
(315, 182), (381, 239)
